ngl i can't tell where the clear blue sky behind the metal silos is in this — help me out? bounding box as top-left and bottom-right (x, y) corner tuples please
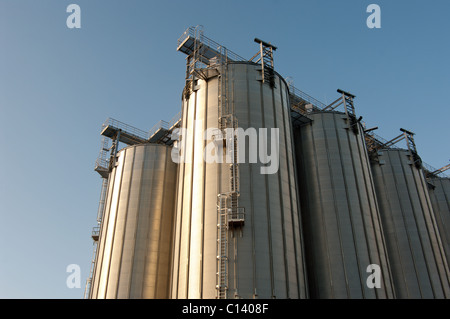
(0, 0), (450, 298)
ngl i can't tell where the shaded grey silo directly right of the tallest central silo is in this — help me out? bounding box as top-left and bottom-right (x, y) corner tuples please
(294, 111), (394, 299)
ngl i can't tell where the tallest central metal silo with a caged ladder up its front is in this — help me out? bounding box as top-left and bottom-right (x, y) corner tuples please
(172, 62), (307, 299)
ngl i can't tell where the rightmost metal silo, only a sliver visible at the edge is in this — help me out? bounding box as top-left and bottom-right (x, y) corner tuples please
(428, 178), (450, 265)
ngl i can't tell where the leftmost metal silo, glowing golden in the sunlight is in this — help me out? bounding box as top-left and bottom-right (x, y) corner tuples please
(90, 144), (177, 299)
